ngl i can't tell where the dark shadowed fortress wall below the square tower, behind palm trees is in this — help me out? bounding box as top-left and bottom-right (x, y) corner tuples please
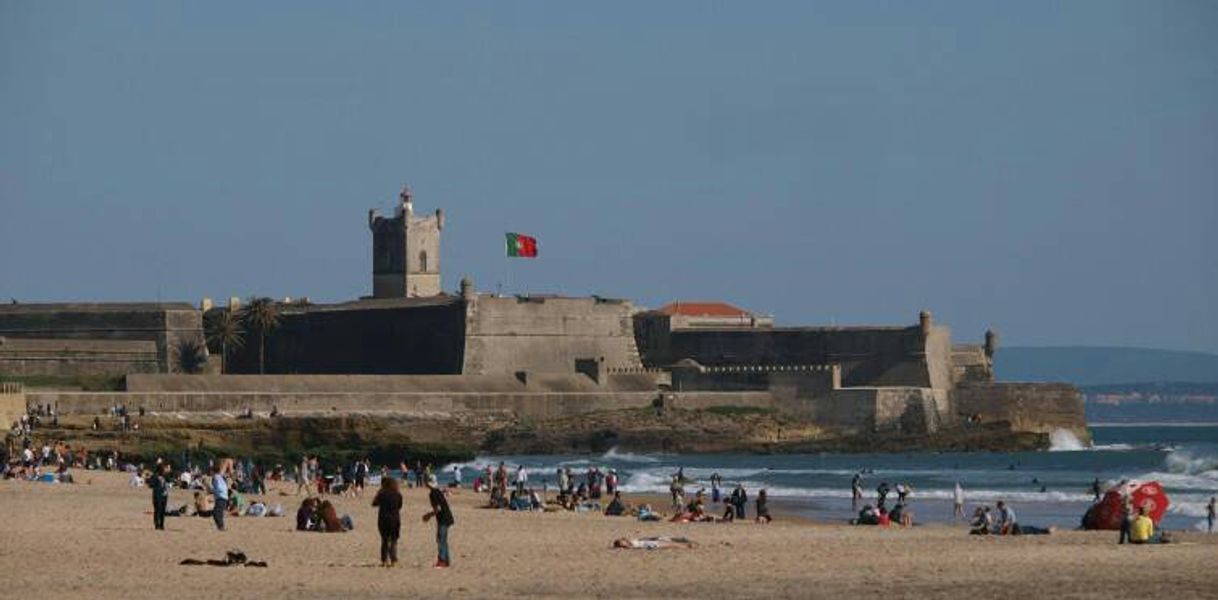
(228, 298), (464, 374)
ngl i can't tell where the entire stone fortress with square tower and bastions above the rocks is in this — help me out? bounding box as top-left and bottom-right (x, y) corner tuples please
(0, 189), (1086, 445)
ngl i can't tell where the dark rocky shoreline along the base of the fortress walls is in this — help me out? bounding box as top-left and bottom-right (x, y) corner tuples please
(14, 408), (1071, 464)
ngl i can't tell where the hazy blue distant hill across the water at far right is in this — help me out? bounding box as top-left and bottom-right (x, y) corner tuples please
(994, 346), (1218, 386)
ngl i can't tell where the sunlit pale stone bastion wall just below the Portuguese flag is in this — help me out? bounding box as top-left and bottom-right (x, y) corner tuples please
(462, 296), (642, 374)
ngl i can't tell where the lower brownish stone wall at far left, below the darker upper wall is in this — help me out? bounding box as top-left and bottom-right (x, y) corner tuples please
(0, 338), (161, 376)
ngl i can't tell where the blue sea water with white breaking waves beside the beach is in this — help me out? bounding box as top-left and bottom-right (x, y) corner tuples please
(450, 424), (1218, 529)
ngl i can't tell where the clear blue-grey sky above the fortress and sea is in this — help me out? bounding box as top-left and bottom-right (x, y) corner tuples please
(0, 0), (1218, 352)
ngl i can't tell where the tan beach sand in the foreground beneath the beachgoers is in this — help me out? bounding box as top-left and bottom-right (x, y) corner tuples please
(0, 471), (1218, 600)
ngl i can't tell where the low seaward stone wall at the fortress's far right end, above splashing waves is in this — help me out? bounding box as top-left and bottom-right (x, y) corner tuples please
(951, 382), (1089, 439)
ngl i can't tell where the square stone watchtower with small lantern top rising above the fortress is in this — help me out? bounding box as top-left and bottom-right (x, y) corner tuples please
(368, 185), (445, 298)
